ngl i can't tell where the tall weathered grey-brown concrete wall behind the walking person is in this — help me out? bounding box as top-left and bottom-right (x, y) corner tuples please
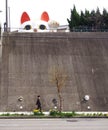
(0, 32), (108, 111)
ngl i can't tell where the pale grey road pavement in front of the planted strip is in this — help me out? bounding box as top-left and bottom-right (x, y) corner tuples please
(0, 118), (108, 130)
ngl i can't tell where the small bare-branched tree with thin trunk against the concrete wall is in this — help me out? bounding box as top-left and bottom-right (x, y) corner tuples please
(50, 66), (67, 112)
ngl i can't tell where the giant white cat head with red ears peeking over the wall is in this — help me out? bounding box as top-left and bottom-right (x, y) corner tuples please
(19, 11), (59, 32)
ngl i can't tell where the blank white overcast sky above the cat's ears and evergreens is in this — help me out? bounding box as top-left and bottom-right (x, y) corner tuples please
(0, 0), (108, 29)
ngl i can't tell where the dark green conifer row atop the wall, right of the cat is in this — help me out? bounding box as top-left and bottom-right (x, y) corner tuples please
(67, 6), (108, 31)
